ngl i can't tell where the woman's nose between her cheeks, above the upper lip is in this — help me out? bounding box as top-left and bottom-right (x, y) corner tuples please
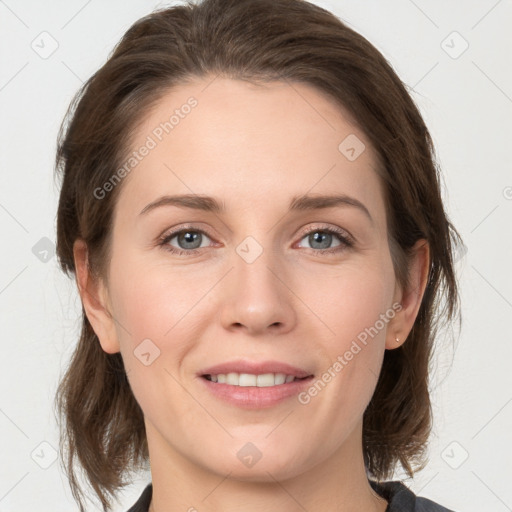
(220, 251), (297, 336)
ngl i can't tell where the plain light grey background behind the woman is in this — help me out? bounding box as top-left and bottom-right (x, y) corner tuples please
(0, 0), (512, 512)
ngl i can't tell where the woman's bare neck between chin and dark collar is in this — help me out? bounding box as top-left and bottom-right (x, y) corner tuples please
(147, 424), (387, 512)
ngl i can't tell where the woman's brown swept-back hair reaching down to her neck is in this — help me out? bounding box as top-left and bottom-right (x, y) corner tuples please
(55, 0), (461, 512)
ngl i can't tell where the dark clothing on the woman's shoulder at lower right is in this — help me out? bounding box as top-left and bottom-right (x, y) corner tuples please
(370, 480), (455, 512)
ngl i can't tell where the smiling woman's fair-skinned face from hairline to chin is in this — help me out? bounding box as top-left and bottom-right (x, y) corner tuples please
(90, 78), (406, 480)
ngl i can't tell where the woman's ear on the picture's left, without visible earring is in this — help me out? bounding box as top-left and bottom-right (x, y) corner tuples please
(73, 239), (120, 354)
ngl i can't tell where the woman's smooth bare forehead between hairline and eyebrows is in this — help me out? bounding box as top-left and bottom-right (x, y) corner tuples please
(113, 77), (384, 222)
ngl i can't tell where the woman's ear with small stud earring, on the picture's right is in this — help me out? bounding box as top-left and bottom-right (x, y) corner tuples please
(386, 239), (430, 350)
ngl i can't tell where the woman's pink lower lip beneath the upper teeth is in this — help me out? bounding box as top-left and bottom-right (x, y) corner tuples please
(200, 376), (313, 409)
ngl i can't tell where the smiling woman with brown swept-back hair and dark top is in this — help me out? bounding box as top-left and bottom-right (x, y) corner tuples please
(57, 0), (460, 512)
